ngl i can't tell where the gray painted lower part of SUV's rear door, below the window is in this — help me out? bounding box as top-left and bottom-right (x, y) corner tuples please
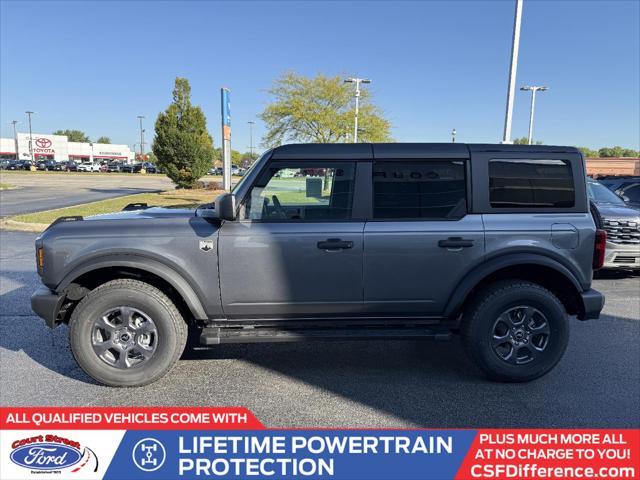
(364, 215), (484, 315)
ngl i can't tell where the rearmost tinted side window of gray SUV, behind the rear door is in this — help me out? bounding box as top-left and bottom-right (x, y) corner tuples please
(489, 159), (575, 208)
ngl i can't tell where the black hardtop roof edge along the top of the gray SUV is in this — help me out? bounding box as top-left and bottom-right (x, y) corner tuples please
(271, 143), (580, 160)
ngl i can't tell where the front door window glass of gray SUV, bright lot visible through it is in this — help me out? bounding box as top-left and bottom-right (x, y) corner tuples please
(244, 162), (355, 222)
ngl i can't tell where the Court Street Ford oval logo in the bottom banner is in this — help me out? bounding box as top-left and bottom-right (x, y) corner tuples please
(10, 435), (83, 472)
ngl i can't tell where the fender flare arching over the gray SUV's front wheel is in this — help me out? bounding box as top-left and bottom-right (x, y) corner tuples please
(56, 254), (208, 320)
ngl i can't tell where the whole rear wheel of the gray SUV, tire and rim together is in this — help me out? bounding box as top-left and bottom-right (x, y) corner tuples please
(461, 281), (569, 382)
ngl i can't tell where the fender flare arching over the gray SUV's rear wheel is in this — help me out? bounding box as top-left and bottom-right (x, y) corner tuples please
(444, 253), (584, 317)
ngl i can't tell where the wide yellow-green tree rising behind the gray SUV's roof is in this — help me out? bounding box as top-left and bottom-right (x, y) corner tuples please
(260, 72), (391, 147)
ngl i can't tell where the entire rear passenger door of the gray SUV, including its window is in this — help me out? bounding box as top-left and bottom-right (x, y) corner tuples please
(364, 150), (484, 316)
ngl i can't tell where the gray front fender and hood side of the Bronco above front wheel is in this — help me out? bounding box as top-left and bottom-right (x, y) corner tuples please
(38, 213), (222, 318)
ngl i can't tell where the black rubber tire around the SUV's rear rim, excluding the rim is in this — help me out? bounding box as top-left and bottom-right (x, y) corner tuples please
(460, 280), (569, 382)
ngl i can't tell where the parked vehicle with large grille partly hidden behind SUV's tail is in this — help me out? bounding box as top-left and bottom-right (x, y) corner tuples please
(587, 179), (640, 270)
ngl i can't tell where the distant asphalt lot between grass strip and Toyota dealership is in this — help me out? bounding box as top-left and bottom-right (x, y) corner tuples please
(0, 172), (173, 217)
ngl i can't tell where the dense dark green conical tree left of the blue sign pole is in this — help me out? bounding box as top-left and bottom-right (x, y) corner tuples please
(152, 77), (213, 188)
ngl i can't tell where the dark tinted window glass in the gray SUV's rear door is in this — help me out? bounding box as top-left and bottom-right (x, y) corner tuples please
(373, 160), (467, 220)
